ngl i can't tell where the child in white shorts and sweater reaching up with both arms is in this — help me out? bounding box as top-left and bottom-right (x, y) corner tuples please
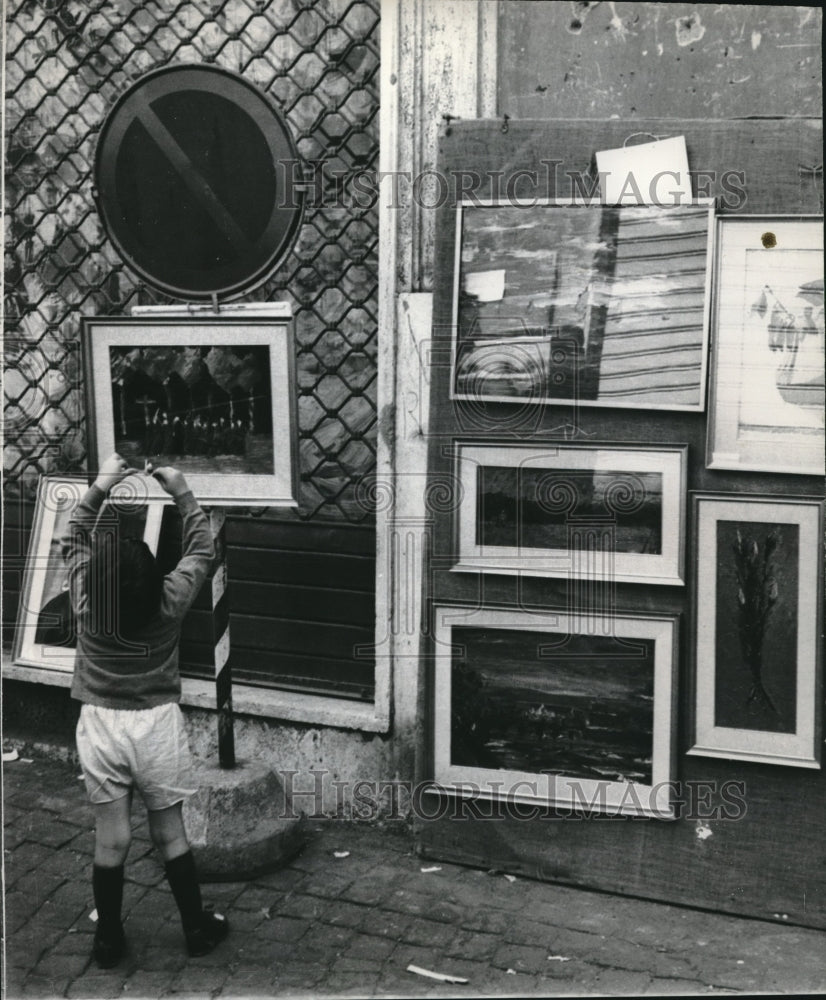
(63, 454), (229, 968)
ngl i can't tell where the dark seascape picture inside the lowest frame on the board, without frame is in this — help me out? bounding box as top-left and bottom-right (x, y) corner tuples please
(450, 626), (655, 784)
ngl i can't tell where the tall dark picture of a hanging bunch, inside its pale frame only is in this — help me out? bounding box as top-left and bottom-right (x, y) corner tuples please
(714, 521), (800, 733)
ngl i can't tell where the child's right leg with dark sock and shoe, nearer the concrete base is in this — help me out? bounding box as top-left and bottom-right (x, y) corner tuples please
(147, 802), (229, 955)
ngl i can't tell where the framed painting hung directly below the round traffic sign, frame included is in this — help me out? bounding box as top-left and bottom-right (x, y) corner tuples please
(83, 317), (297, 506)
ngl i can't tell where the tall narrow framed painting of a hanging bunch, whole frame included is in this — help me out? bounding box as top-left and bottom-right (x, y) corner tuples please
(689, 493), (823, 768)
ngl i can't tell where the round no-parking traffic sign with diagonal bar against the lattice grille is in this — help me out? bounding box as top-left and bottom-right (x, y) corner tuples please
(95, 65), (304, 301)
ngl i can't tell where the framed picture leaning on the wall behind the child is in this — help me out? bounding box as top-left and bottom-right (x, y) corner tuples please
(12, 476), (163, 672)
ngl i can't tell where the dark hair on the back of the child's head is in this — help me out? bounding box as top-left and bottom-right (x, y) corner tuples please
(86, 531), (163, 637)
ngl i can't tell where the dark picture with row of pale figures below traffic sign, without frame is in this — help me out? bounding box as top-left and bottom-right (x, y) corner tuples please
(109, 344), (274, 475)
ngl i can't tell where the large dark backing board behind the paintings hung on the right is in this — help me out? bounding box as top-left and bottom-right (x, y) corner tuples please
(417, 119), (826, 927)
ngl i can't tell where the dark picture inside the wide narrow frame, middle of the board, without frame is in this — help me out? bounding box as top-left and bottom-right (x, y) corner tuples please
(476, 465), (663, 555)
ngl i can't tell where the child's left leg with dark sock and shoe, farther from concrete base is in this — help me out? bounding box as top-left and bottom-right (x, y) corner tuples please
(92, 792), (132, 968)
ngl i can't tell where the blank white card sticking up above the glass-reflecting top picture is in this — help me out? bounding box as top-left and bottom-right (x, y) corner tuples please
(596, 135), (691, 205)
